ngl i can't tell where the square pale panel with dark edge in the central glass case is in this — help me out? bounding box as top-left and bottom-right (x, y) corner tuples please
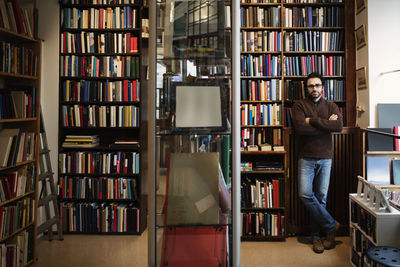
(172, 81), (228, 132)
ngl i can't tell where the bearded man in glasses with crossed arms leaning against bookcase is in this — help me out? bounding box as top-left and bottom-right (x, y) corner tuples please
(292, 72), (343, 253)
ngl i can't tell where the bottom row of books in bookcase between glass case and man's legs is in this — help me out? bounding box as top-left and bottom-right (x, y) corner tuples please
(240, 212), (285, 237)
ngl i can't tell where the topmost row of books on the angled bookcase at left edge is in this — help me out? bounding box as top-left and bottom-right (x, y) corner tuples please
(0, 0), (36, 37)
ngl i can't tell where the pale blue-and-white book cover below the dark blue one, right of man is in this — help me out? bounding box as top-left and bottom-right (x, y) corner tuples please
(366, 156), (390, 185)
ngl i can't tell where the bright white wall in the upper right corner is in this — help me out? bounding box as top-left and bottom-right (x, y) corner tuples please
(367, 0), (400, 127)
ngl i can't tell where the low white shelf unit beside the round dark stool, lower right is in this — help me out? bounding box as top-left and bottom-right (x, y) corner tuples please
(349, 177), (400, 266)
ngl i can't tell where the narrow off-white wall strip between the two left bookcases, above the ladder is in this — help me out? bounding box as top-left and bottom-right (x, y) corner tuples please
(36, 0), (59, 181)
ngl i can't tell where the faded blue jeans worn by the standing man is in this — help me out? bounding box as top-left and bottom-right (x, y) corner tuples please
(298, 158), (335, 237)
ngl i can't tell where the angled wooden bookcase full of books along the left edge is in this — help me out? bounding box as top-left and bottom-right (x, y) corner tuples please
(0, 1), (41, 266)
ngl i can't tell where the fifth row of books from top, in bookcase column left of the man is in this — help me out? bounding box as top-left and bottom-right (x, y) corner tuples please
(240, 103), (282, 126)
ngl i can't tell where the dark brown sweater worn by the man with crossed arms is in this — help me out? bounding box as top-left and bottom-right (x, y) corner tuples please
(291, 98), (343, 158)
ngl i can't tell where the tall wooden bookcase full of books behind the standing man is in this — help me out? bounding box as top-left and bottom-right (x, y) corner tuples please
(236, 0), (355, 240)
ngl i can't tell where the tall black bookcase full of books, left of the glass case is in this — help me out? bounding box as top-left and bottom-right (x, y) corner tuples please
(58, 0), (147, 234)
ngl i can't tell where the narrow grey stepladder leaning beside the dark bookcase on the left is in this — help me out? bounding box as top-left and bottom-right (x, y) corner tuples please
(37, 111), (64, 241)
